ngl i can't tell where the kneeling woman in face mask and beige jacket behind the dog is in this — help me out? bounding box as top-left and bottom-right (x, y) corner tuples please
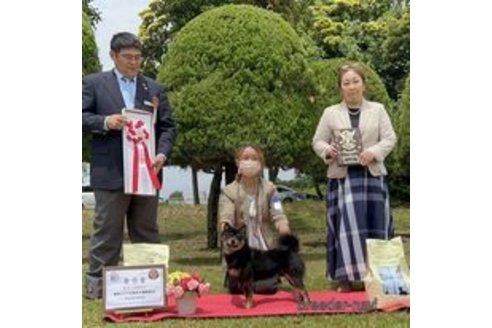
(219, 145), (290, 294)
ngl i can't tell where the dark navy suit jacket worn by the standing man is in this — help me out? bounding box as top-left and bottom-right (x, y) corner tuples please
(82, 71), (176, 190)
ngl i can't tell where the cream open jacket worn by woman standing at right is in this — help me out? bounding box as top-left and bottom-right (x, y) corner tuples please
(312, 99), (396, 179)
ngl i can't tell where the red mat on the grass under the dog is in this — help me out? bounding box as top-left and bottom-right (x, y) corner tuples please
(105, 291), (410, 322)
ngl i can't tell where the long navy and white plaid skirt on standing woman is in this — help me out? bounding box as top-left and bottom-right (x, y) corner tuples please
(326, 166), (393, 281)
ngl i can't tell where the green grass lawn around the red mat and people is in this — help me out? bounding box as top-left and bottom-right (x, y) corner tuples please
(81, 201), (410, 328)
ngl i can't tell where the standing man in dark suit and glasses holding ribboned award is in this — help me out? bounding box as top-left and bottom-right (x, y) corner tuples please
(82, 32), (176, 299)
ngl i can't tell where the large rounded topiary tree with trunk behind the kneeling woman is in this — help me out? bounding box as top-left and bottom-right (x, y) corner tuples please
(158, 5), (314, 248)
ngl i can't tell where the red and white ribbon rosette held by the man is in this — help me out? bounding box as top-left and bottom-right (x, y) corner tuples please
(125, 120), (161, 194)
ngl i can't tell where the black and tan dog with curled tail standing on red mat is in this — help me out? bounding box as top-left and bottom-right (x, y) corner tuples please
(221, 223), (309, 308)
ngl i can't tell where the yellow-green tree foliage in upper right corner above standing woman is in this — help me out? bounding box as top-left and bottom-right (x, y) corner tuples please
(310, 0), (410, 100)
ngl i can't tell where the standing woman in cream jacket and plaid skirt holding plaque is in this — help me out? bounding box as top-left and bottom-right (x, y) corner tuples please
(312, 64), (396, 292)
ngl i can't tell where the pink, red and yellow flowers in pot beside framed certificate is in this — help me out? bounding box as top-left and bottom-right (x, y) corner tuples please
(167, 271), (210, 298)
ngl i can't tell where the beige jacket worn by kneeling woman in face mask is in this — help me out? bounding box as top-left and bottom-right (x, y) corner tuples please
(218, 178), (289, 247)
